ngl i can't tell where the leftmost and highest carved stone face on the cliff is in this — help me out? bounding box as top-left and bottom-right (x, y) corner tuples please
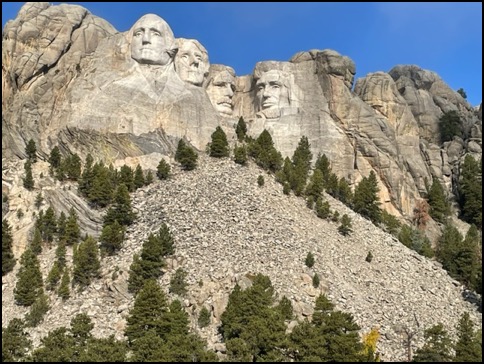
(131, 14), (175, 65)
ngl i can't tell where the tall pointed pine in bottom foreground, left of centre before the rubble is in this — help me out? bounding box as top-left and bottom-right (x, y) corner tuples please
(125, 279), (167, 344)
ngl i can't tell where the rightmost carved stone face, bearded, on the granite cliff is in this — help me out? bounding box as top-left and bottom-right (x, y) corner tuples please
(256, 70), (289, 111)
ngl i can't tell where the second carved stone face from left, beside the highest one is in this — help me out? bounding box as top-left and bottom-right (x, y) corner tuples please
(175, 39), (209, 86)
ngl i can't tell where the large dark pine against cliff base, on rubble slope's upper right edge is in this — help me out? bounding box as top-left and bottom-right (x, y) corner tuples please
(353, 171), (381, 224)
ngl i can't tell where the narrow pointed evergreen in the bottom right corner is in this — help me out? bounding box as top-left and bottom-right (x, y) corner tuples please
(454, 312), (482, 363)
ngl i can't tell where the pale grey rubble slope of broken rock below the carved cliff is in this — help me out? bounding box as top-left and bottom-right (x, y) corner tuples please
(2, 155), (482, 361)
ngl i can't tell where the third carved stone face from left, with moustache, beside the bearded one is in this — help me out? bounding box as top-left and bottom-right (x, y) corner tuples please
(207, 71), (235, 116)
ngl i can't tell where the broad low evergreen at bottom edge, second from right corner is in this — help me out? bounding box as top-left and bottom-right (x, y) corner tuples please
(413, 323), (453, 363)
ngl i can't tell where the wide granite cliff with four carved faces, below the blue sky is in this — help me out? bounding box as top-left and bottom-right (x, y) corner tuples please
(2, 3), (482, 216)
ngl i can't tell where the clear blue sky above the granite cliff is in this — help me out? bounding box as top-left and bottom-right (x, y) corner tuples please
(2, 2), (482, 105)
